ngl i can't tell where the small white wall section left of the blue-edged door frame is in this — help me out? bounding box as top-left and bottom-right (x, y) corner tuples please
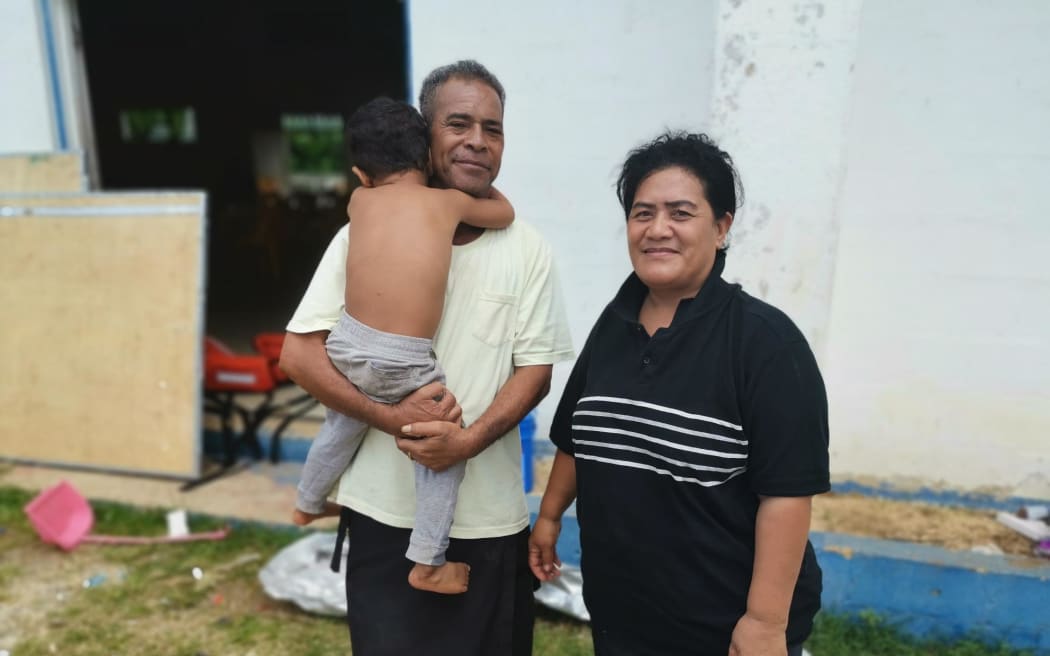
(0, 0), (56, 153)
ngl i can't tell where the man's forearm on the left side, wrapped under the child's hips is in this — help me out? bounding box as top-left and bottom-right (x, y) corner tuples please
(280, 331), (463, 435)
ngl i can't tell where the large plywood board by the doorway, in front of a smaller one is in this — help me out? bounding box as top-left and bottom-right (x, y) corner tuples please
(0, 192), (205, 478)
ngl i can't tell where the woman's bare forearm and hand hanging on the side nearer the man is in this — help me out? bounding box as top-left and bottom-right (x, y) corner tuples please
(528, 449), (576, 580)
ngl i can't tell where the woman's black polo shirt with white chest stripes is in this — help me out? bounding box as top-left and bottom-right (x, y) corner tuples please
(551, 254), (830, 656)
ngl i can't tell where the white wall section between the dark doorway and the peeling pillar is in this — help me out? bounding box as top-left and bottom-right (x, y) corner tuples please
(410, 0), (716, 445)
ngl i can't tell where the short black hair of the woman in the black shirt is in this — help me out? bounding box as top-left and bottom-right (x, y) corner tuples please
(616, 132), (743, 250)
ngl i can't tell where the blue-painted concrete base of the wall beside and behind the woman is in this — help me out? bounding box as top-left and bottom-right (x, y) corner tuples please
(529, 510), (1050, 655)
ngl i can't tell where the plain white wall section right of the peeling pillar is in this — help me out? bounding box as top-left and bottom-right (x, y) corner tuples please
(824, 0), (1050, 498)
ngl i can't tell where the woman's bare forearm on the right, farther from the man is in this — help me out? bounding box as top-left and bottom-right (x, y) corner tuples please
(729, 496), (813, 656)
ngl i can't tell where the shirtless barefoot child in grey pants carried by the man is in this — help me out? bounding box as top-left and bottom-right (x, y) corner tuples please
(292, 98), (513, 594)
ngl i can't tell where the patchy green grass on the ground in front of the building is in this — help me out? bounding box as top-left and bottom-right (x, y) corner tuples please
(0, 487), (1025, 656)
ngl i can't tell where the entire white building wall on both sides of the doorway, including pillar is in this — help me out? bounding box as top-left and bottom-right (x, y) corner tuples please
(0, 0), (1050, 499)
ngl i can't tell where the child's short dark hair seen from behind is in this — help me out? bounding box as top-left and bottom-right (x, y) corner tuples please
(347, 98), (431, 177)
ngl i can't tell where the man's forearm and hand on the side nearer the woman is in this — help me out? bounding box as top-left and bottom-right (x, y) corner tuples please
(395, 364), (553, 471)
